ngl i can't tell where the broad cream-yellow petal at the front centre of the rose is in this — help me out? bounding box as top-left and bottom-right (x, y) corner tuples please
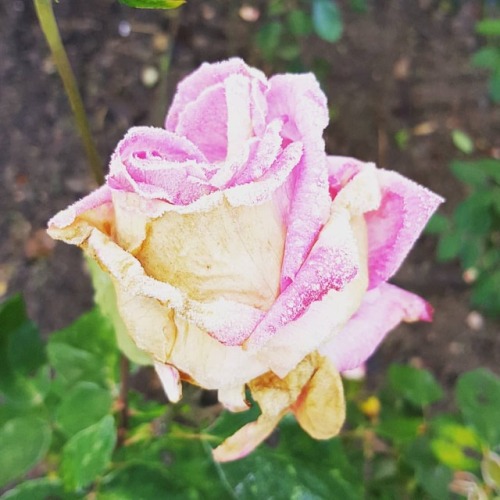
(131, 201), (285, 310)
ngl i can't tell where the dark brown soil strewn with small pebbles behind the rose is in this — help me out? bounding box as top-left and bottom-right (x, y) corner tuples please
(0, 0), (500, 387)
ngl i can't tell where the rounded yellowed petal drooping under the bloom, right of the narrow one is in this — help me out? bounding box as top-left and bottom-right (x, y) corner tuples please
(293, 356), (345, 439)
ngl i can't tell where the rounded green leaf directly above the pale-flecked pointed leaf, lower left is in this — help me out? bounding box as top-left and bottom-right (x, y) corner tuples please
(56, 382), (113, 436)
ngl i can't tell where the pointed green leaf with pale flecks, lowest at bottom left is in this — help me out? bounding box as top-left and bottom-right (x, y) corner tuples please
(61, 415), (116, 491)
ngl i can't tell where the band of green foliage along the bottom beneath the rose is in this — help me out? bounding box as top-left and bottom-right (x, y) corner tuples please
(0, 294), (500, 500)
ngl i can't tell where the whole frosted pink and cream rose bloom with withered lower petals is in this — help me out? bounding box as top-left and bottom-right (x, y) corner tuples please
(49, 59), (441, 461)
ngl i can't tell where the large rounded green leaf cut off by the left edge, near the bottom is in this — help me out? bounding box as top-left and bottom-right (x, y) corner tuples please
(0, 417), (52, 486)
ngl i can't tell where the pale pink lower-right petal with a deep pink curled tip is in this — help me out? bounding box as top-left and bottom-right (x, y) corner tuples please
(320, 283), (432, 372)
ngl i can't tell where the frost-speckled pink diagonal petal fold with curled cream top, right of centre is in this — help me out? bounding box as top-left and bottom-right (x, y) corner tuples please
(245, 167), (380, 352)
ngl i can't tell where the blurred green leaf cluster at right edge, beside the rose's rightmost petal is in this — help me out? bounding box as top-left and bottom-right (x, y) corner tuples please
(427, 158), (500, 317)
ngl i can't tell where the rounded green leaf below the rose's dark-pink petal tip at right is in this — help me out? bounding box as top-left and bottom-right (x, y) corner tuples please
(388, 364), (443, 407)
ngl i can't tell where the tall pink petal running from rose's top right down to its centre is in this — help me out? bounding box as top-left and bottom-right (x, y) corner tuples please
(267, 74), (331, 289)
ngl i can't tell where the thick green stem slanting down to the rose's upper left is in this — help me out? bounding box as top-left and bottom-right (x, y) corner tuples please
(33, 0), (104, 184)
